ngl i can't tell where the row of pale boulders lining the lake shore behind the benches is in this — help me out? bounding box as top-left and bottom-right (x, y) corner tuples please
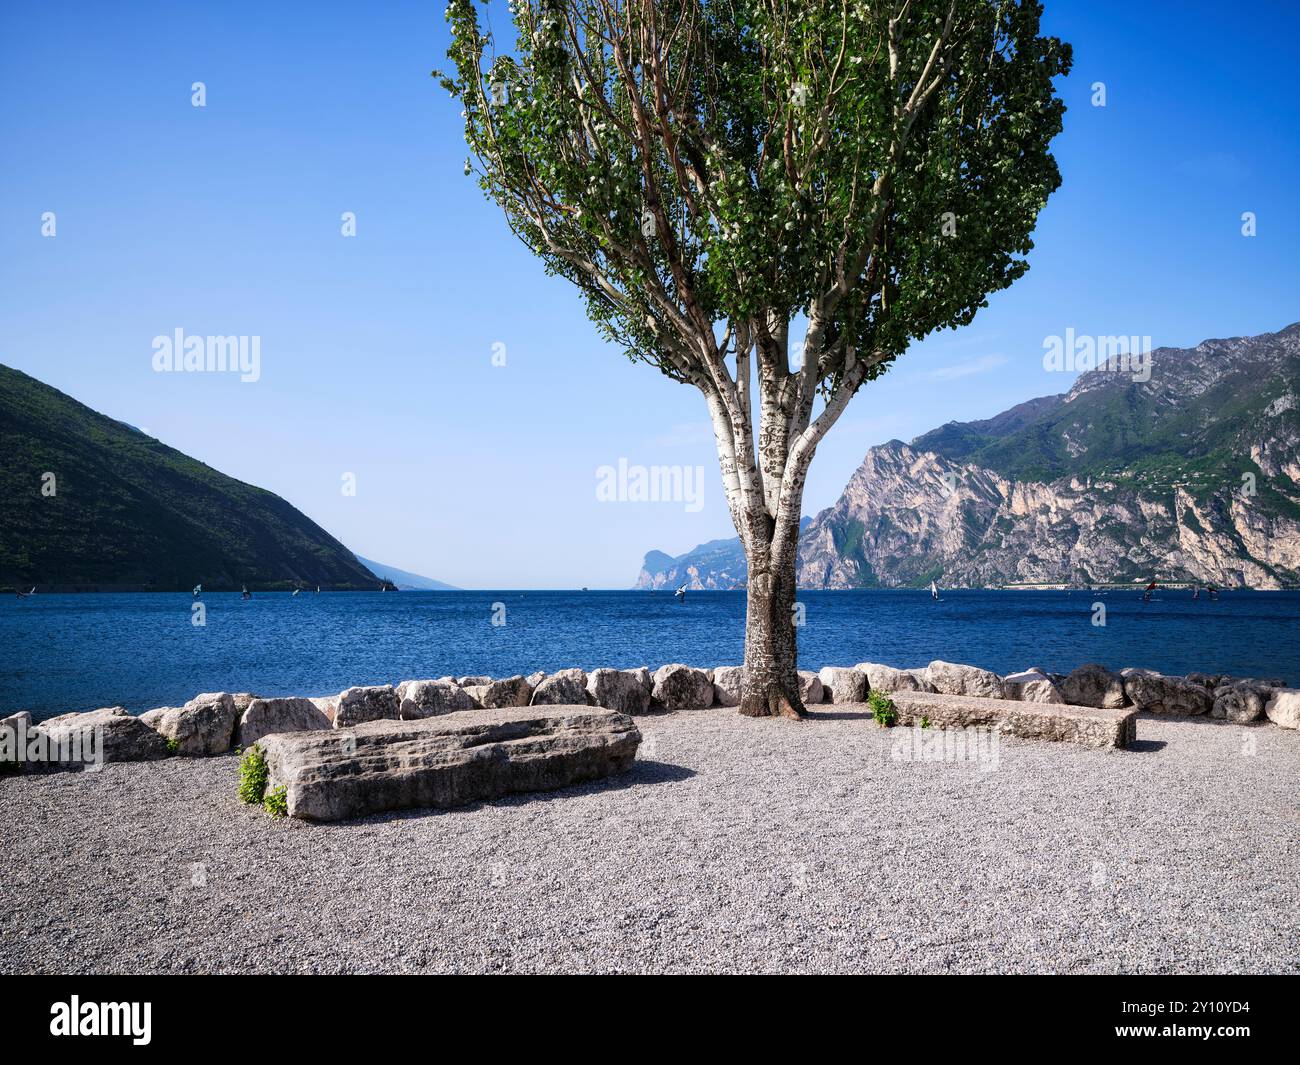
(0, 661), (1300, 762)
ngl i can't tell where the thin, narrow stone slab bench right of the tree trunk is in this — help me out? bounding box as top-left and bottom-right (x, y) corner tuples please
(891, 692), (1138, 749)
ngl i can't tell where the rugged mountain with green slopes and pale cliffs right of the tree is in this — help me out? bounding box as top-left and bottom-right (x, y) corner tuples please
(638, 322), (1300, 588)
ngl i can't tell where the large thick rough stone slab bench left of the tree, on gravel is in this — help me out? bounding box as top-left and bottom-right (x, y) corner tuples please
(257, 706), (641, 821)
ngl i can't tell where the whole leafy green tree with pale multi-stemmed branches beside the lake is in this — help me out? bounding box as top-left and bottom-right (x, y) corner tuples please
(434, 0), (1070, 717)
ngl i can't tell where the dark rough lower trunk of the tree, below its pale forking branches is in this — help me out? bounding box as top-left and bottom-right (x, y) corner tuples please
(740, 520), (807, 718)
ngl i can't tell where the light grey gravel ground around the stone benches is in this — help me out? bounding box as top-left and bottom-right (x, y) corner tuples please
(0, 707), (1300, 973)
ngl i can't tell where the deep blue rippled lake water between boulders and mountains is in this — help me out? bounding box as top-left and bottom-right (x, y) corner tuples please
(0, 590), (1300, 718)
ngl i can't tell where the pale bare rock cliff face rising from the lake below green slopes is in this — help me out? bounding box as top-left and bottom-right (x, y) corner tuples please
(800, 441), (1300, 588)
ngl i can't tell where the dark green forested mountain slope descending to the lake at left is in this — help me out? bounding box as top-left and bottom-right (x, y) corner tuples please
(0, 367), (378, 590)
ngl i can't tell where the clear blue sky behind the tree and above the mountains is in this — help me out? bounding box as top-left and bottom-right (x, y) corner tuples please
(0, 0), (1300, 588)
